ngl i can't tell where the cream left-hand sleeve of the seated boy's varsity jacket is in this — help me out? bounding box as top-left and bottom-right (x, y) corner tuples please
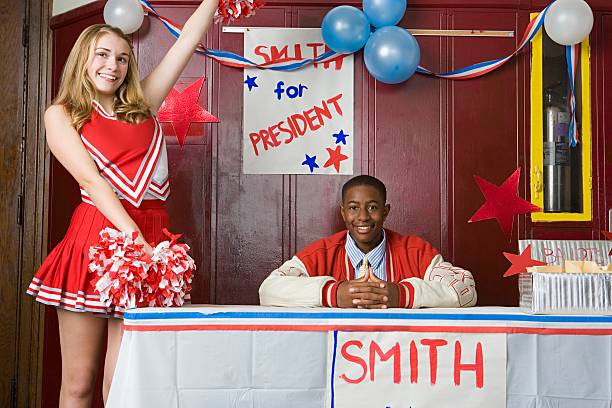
(259, 256), (334, 307)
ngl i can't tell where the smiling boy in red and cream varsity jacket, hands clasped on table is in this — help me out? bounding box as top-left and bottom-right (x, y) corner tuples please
(259, 176), (476, 309)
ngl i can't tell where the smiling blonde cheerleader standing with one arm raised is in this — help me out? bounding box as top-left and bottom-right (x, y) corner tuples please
(28, 0), (218, 407)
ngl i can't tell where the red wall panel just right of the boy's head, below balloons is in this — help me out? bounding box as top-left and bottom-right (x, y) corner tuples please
(368, 10), (446, 248)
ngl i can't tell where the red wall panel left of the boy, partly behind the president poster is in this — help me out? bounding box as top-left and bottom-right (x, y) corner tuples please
(211, 7), (291, 304)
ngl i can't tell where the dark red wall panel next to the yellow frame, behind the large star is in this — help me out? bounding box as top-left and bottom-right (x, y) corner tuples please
(448, 10), (526, 305)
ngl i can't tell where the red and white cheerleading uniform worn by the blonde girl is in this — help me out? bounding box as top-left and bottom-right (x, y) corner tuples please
(27, 101), (170, 317)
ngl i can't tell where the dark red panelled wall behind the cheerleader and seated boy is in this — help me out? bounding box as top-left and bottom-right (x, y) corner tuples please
(43, 0), (612, 407)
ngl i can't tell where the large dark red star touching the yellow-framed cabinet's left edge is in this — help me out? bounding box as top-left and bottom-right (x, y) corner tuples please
(468, 167), (542, 240)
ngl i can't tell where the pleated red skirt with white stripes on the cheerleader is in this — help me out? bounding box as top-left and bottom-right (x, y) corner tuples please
(27, 200), (168, 317)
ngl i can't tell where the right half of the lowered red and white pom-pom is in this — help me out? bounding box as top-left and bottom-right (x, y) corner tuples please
(143, 237), (196, 307)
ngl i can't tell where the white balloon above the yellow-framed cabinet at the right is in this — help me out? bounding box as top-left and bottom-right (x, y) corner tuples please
(544, 0), (593, 45)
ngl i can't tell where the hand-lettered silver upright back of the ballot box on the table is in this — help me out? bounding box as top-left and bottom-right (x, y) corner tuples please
(519, 239), (612, 265)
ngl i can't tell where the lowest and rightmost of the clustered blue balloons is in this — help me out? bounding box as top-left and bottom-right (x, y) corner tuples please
(363, 26), (421, 84)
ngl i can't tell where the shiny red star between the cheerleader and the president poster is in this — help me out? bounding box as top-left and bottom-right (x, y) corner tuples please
(157, 77), (220, 147)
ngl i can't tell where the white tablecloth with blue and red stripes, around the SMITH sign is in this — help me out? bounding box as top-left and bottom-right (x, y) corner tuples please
(107, 306), (612, 408)
